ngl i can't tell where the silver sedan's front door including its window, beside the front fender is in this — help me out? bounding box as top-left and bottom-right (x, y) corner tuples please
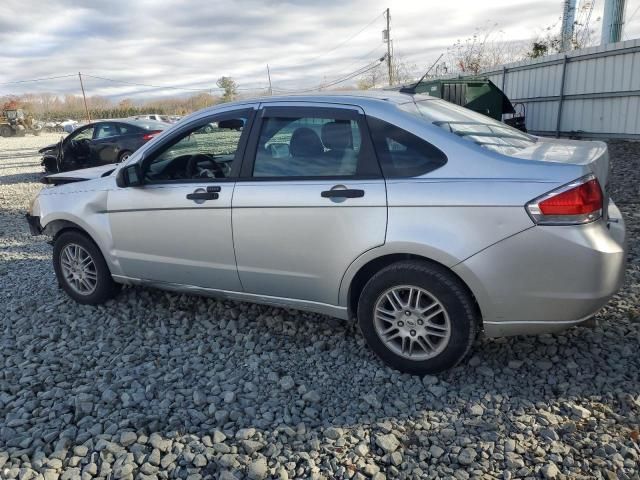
(108, 106), (253, 291)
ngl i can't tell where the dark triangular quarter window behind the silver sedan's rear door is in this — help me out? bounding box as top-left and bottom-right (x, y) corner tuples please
(367, 117), (447, 178)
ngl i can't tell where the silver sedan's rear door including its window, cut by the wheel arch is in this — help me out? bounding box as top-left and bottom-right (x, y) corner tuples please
(232, 103), (387, 305)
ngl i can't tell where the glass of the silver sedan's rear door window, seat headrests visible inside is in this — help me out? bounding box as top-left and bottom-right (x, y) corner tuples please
(253, 114), (371, 178)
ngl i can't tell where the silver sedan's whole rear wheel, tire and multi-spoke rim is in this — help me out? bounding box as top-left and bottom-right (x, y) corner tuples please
(358, 261), (478, 375)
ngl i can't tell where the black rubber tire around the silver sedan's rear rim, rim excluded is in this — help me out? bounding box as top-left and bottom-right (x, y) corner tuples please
(358, 261), (479, 375)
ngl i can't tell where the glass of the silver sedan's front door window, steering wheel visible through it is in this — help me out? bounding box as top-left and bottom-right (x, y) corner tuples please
(143, 112), (248, 183)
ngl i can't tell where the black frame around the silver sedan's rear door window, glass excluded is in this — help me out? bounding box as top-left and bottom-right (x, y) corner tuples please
(238, 104), (383, 182)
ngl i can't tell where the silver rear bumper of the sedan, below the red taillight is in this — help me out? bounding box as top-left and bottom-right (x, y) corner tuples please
(454, 202), (627, 337)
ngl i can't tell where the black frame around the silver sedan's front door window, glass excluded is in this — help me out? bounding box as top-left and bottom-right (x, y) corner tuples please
(138, 106), (256, 185)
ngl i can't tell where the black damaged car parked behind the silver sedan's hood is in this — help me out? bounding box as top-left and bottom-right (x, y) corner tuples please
(39, 120), (168, 173)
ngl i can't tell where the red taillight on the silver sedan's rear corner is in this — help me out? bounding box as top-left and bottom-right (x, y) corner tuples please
(526, 175), (603, 225)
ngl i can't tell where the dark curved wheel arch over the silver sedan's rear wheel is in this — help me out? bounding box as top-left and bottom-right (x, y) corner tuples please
(341, 252), (482, 327)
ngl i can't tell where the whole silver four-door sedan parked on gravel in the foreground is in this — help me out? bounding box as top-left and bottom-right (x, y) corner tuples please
(27, 92), (626, 374)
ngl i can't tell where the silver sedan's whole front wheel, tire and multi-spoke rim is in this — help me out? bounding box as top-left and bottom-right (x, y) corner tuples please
(53, 231), (120, 305)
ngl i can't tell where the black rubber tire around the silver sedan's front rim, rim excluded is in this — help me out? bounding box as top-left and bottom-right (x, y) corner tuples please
(53, 230), (121, 305)
